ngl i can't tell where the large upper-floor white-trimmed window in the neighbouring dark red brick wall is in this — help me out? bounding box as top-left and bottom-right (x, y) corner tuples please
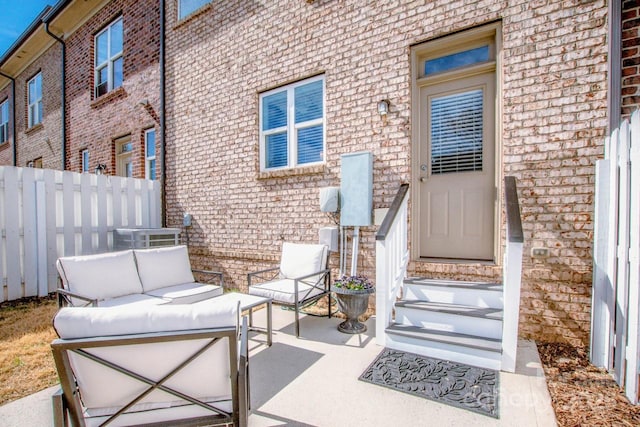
(94, 17), (123, 98)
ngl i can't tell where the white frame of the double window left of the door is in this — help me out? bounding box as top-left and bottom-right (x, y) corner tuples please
(258, 74), (327, 172)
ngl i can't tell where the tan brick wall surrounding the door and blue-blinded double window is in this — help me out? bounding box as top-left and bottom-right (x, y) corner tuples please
(166, 0), (607, 343)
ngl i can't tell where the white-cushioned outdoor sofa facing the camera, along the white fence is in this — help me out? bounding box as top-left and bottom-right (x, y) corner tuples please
(56, 246), (224, 307)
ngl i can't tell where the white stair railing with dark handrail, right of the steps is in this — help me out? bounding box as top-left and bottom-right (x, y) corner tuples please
(501, 176), (524, 372)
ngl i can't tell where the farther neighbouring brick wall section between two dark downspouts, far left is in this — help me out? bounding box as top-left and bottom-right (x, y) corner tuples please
(8, 43), (62, 169)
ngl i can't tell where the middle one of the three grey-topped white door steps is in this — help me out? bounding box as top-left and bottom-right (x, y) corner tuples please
(395, 300), (502, 339)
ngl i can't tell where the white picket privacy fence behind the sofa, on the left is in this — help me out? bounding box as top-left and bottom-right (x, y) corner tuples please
(0, 166), (162, 302)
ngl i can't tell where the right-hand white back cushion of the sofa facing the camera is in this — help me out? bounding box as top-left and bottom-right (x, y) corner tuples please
(134, 246), (195, 292)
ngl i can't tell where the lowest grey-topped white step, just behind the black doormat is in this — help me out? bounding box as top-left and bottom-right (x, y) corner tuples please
(385, 324), (502, 370)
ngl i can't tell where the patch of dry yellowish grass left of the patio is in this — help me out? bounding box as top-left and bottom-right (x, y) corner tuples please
(0, 298), (58, 405)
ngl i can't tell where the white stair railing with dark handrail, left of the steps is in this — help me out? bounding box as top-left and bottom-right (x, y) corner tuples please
(376, 184), (409, 346)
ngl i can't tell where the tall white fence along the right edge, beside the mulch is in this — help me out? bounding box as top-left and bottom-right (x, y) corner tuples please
(591, 111), (640, 404)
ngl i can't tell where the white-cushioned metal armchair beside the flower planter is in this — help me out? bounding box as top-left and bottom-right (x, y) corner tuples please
(247, 242), (331, 337)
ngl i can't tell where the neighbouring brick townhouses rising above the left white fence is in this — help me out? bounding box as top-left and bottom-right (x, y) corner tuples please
(0, 0), (161, 178)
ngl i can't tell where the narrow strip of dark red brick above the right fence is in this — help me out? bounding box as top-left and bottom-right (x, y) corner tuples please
(622, 0), (640, 118)
